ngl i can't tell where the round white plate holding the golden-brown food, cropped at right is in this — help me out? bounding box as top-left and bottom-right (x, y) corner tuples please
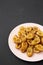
(8, 23), (43, 62)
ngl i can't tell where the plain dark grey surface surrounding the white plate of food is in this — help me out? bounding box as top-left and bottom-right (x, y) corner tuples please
(0, 0), (43, 65)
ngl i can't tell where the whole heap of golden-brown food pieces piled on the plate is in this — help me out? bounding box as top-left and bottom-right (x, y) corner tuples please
(13, 26), (43, 57)
